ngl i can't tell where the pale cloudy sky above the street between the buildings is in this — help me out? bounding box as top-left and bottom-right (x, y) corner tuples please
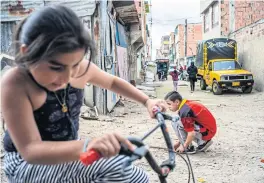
(148, 0), (201, 59)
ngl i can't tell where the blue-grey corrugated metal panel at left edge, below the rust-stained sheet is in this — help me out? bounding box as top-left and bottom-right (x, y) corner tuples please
(1, 21), (16, 54)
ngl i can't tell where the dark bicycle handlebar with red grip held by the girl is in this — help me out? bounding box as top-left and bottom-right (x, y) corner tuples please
(80, 108), (179, 183)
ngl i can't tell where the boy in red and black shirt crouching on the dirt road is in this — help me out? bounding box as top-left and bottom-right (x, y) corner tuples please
(165, 91), (217, 154)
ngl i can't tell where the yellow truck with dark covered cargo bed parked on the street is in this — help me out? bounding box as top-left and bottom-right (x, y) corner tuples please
(196, 38), (254, 95)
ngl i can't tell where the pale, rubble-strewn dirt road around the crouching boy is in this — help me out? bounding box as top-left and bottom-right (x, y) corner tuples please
(2, 81), (264, 183)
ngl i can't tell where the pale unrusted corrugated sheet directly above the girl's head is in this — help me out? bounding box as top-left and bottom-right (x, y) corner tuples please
(45, 0), (96, 17)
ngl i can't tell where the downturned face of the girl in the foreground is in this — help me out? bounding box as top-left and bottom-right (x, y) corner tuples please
(29, 49), (85, 91)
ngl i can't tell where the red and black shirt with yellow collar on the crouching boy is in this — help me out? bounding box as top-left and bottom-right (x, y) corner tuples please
(179, 100), (217, 140)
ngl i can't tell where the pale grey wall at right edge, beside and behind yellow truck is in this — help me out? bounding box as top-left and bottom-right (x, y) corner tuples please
(230, 19), (264, 91)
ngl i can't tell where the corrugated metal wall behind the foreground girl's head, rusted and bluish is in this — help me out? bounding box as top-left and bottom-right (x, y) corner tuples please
(1, 0), (96, 54)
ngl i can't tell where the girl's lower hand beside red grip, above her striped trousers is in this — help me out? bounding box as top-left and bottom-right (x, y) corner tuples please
(87, 133), (134, 158)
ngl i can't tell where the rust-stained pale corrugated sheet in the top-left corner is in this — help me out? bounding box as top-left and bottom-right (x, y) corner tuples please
(1, 0), (44, 22)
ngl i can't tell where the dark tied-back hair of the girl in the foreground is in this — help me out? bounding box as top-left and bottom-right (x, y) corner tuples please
(14, 5), (95, 71)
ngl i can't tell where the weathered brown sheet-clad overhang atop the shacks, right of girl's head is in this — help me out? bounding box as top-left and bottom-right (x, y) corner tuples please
(113, 0), (139, 24)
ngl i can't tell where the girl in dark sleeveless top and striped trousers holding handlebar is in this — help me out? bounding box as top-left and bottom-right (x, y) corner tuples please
(1, 5), (162, 183)
